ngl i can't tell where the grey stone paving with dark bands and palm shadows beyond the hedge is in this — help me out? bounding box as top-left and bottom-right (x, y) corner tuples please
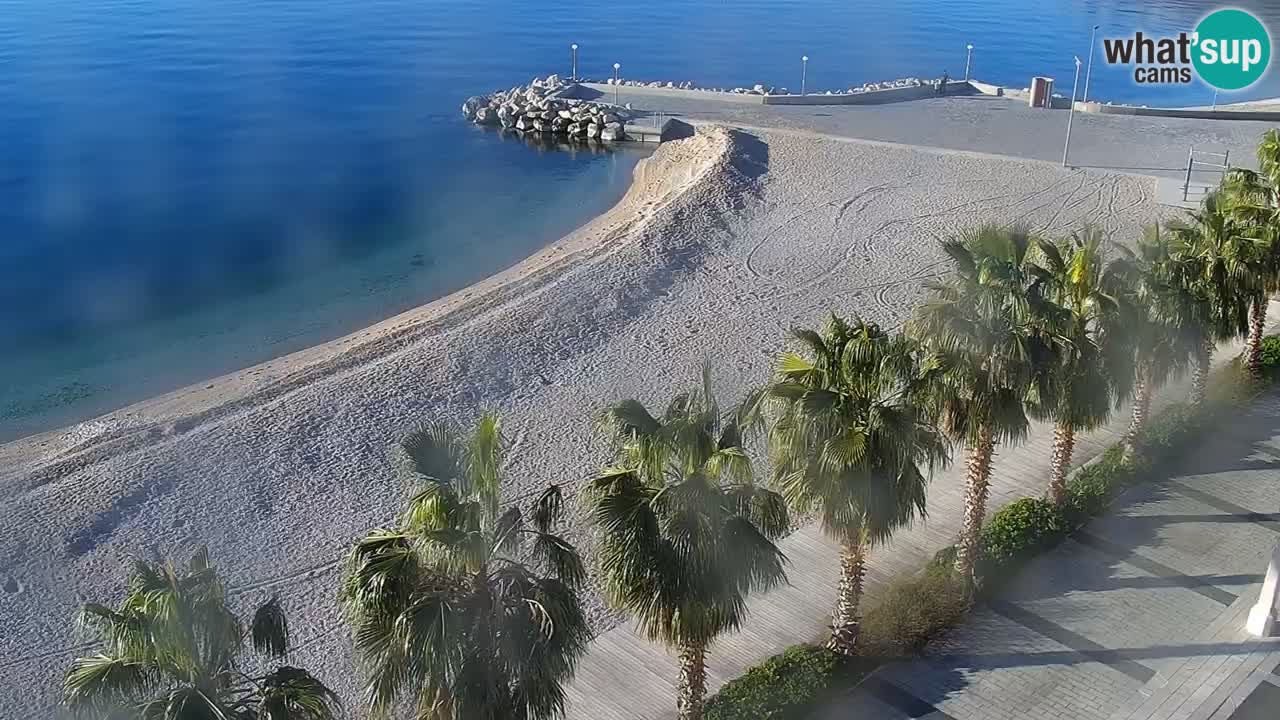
(814, 391), (1280, 720)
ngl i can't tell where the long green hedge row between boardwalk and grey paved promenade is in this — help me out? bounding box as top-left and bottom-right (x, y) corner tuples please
(705, 336), (1280, 720)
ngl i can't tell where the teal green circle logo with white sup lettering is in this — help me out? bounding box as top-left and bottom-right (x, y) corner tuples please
(1192, 8), (1271, 90)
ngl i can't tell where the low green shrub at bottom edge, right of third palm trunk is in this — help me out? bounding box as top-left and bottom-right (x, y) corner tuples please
(704, 644), (849, 720)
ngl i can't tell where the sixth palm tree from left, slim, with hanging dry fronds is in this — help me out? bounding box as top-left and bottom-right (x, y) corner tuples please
(1030, 229), (1133, 503)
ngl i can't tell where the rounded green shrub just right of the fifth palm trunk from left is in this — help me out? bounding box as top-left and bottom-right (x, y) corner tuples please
(979, 497), (1068, 580)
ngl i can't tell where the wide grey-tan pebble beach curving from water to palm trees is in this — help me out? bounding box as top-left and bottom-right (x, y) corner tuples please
(0, 119), (1167, 717)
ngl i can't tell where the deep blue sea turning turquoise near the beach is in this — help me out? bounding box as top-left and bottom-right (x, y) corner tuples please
(0, 0), (1280, 439)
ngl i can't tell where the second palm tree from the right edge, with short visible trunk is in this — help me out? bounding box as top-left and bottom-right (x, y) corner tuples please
(1167, 191), (1261, 397)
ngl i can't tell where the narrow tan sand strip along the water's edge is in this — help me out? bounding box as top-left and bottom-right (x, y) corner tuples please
(0, 129), (742, 486)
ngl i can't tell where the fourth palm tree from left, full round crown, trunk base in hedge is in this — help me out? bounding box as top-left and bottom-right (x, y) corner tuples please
(764, 315), (947, 655)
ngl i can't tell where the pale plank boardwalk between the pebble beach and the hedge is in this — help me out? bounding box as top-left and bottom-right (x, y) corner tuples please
(567, 302), (1280, 720)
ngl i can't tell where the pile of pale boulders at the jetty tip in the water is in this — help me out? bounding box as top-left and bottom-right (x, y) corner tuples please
(462, 76), (627, 142)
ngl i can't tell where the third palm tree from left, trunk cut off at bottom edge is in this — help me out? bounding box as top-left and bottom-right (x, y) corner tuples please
(590, 369), (788, 720)
